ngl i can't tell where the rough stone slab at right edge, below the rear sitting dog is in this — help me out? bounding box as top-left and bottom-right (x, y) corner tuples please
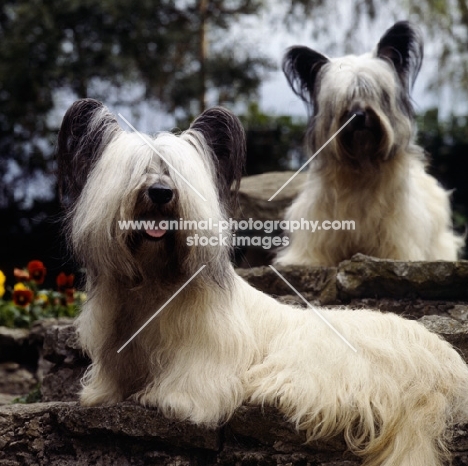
(337, 254), (468, 301)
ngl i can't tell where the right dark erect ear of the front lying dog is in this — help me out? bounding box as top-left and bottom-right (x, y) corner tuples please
(190, 107), (246, 212)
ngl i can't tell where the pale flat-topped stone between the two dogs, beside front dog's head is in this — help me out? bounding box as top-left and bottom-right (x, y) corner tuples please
(237, 171), (307, 221)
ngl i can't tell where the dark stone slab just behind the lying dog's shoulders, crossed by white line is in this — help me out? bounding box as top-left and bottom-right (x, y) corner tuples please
(236, 265), (337, 304)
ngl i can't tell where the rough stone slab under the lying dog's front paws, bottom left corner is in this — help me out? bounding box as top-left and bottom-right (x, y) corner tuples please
(0, 402), (220, 466)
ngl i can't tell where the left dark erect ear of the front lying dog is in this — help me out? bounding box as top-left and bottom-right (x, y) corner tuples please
(56, 99), (119, 207)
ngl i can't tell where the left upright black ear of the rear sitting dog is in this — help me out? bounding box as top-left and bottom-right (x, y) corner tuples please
(283, 46), (329, 104)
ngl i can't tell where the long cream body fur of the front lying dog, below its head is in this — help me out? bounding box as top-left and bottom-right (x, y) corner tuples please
(79, 271), (468, 466)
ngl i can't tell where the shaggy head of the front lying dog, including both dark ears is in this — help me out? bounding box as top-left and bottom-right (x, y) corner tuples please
(57, 99), (245, 284)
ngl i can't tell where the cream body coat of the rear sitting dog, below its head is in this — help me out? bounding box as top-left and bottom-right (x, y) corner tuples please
(276, 152), (464, 266)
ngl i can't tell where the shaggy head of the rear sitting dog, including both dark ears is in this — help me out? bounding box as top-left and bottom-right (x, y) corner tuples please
(283, 21), (423, 168)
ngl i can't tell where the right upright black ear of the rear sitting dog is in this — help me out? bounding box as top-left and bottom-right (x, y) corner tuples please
(377, 21), (424, 92)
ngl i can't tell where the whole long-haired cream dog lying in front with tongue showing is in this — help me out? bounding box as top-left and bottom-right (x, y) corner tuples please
(58, 99), (468, 466)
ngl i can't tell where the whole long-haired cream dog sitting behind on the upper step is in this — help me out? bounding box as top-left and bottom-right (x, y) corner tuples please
(276, 22), (464, 266)
